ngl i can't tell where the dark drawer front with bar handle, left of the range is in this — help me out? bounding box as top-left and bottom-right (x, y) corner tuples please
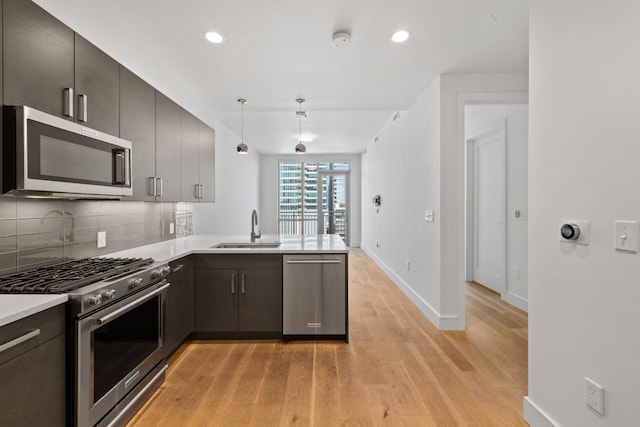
(0, 304), (65, 364)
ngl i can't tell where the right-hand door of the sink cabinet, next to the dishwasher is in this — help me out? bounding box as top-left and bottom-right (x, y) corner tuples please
(239, 268), (282, 332)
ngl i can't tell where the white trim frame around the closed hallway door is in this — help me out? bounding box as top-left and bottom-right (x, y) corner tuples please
(465, 119), (507, 296)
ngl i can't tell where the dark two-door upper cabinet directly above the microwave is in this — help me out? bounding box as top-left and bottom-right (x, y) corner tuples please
(3, 0), (119, 135)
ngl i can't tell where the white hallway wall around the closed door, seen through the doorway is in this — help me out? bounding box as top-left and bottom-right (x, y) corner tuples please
(465, 104), (529, 310)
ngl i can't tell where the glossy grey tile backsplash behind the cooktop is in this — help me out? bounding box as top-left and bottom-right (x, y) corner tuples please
(0, 197), (193, 275)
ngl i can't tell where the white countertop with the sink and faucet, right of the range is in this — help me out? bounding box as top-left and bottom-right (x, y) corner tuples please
(105, 234), (349, 263)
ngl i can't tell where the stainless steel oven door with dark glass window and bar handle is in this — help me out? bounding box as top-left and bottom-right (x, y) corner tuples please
(75, 280), (169, 426)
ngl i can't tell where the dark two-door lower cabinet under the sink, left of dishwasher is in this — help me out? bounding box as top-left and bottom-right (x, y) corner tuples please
(195, 255), (282, 338)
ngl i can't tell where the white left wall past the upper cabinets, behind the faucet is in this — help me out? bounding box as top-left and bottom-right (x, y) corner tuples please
(193, 118), (260, 237)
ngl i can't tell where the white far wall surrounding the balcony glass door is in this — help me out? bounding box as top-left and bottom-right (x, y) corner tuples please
(260, 154), (361, 247)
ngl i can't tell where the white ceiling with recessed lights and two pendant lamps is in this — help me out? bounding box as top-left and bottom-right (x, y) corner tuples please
(35, 0), (528, 154)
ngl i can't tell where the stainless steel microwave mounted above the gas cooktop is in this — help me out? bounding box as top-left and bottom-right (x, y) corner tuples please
(2, 106), (133, 199)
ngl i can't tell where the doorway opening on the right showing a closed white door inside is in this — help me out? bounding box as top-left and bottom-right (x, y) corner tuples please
(464, 103), (528, 311)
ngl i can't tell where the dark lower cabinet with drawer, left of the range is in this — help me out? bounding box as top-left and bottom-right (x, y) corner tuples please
(0, 306), (66, 427)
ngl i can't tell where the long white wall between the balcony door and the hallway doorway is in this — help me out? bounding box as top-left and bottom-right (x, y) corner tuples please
(362, 78), (441, 324)
